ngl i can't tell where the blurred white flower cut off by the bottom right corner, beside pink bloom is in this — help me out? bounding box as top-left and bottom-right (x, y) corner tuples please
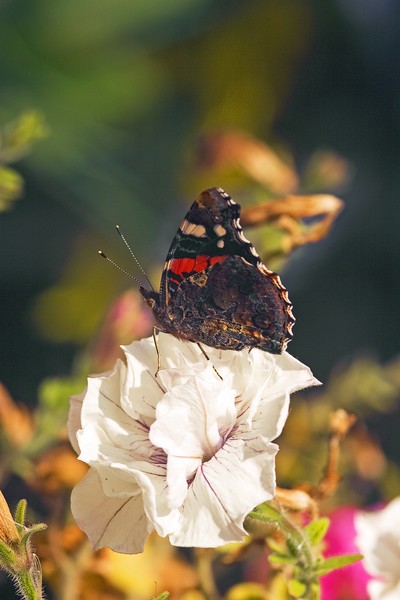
(355, 497), (400, 600)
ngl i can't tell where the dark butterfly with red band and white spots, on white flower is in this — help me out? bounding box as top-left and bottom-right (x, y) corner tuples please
(140, 188), (295, 354)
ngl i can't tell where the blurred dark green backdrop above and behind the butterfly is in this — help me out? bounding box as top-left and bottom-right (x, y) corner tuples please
(0, 0), (400, 596)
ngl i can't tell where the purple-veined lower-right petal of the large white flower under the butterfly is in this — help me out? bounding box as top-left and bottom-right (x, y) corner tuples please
(170, 440), (278, 548)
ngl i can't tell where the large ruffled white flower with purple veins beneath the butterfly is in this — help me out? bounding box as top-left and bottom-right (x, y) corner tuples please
(68, 333), (319, 553)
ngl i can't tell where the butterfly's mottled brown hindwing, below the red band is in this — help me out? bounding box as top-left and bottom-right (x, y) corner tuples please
(167, 256), (294, 354)
